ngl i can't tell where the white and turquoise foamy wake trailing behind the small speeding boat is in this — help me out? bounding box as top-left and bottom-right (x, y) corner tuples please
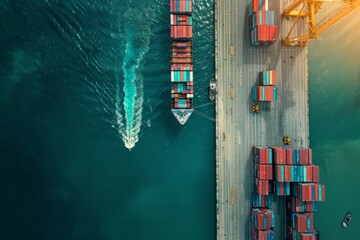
(116, 8), (150, 149)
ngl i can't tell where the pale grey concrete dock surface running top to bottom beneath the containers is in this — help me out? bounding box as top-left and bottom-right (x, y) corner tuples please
(214, 0), (309, 240)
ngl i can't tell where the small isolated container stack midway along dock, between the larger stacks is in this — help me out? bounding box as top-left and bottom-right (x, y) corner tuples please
(252, 70), (277, 102)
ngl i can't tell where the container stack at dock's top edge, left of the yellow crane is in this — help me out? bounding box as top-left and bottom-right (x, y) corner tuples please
(249, 0), (278, 46)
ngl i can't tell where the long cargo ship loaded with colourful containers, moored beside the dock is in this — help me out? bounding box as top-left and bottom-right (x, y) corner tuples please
(170, 0), (194, 125)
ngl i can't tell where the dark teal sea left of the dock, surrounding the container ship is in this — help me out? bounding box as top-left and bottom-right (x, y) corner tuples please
(0, 0), (216, 240)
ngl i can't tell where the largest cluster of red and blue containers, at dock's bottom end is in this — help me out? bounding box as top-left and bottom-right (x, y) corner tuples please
(251, 146), (325, 240)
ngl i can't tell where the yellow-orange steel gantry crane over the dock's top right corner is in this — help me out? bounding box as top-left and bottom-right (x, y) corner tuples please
(283, 0), (360, 47)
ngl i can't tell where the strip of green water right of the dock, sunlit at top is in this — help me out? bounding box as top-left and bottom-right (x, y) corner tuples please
(309, 10), (360, 240)
